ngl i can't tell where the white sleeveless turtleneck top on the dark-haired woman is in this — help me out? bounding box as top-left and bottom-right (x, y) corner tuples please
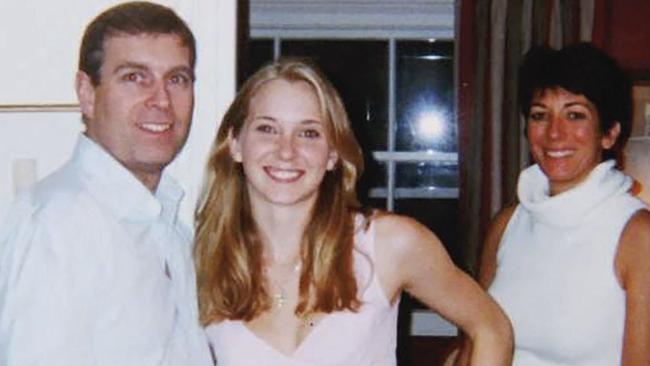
(489, 161), (645, 366)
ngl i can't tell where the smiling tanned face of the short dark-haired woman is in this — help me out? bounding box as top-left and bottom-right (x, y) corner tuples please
(527, 88), (620, 195)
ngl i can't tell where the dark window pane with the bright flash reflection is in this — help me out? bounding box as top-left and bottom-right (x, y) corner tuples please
(396, 41), (458, 152)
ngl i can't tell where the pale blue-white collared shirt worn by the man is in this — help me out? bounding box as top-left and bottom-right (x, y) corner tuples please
(0, 135), (212, 366)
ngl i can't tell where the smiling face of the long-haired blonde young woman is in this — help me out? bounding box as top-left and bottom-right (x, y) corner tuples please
(230, 79), (337, 207)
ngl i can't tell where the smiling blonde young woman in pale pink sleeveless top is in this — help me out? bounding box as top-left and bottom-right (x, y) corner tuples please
(195, 60), (512, 366)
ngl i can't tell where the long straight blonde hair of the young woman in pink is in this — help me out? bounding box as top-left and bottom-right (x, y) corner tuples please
(194, 59), (363, 324)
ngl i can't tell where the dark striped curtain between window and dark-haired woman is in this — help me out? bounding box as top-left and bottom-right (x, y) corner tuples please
(456, 0), (606, 273)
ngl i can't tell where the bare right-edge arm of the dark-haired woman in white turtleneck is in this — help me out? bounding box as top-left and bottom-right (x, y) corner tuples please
(616, 210), (650, 366)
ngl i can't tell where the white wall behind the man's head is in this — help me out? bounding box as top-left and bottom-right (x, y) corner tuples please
(0, 0), (236, 223)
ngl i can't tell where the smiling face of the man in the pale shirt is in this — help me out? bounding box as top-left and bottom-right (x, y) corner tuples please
(76, 34), (194, 191)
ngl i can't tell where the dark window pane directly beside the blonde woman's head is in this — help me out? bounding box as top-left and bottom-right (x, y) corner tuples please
(281, 40), (388, 203)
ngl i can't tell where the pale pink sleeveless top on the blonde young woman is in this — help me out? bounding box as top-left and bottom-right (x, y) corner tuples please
(206, 216), (398, 366)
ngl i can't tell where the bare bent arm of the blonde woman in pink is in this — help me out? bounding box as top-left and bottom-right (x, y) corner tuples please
(376, 215), (512, 366)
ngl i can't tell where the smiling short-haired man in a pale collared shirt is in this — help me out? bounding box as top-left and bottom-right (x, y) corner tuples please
(0, 2), (212, 366)
